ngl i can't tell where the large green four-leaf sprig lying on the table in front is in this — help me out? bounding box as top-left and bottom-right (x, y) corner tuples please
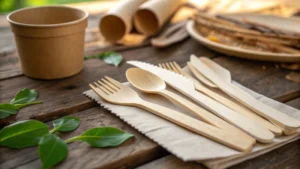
(0, 116), (133, 169)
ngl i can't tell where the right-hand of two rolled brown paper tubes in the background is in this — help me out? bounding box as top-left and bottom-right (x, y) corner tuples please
(133, 0), (187, 35)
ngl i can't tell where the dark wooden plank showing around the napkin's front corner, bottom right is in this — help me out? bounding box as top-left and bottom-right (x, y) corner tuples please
(137, 140), (300, 169)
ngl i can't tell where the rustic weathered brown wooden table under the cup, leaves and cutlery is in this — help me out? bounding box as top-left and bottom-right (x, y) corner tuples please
(0, 11), (300, 169)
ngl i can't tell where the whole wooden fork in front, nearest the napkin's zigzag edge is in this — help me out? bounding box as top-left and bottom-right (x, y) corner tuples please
(90, 77), (255, 152)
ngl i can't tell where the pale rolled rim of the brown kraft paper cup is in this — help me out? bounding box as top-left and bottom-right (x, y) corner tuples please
(6, 5), (89, 28)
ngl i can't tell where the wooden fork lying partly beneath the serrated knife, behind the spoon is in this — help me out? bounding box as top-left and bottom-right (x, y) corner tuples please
(159, 62), (283, 136)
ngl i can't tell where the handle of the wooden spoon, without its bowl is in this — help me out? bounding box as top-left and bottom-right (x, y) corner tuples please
(158, 90), (254, 140)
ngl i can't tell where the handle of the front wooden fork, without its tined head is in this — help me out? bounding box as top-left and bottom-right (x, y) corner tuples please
(135, 100), (255, 152)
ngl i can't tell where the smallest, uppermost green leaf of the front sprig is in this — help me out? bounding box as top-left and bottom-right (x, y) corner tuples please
(52, 116), (80, 132)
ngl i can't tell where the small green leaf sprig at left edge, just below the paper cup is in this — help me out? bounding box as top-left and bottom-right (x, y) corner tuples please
(0, 88), (42, 119)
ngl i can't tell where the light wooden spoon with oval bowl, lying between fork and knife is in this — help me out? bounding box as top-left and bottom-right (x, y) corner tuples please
(126, 68), (255, 143)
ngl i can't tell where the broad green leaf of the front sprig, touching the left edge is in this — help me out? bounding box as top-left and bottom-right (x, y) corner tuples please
(0, 120), (49, 148)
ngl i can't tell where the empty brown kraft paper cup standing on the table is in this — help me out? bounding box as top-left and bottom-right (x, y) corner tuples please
(7, 6), (88, 79)
